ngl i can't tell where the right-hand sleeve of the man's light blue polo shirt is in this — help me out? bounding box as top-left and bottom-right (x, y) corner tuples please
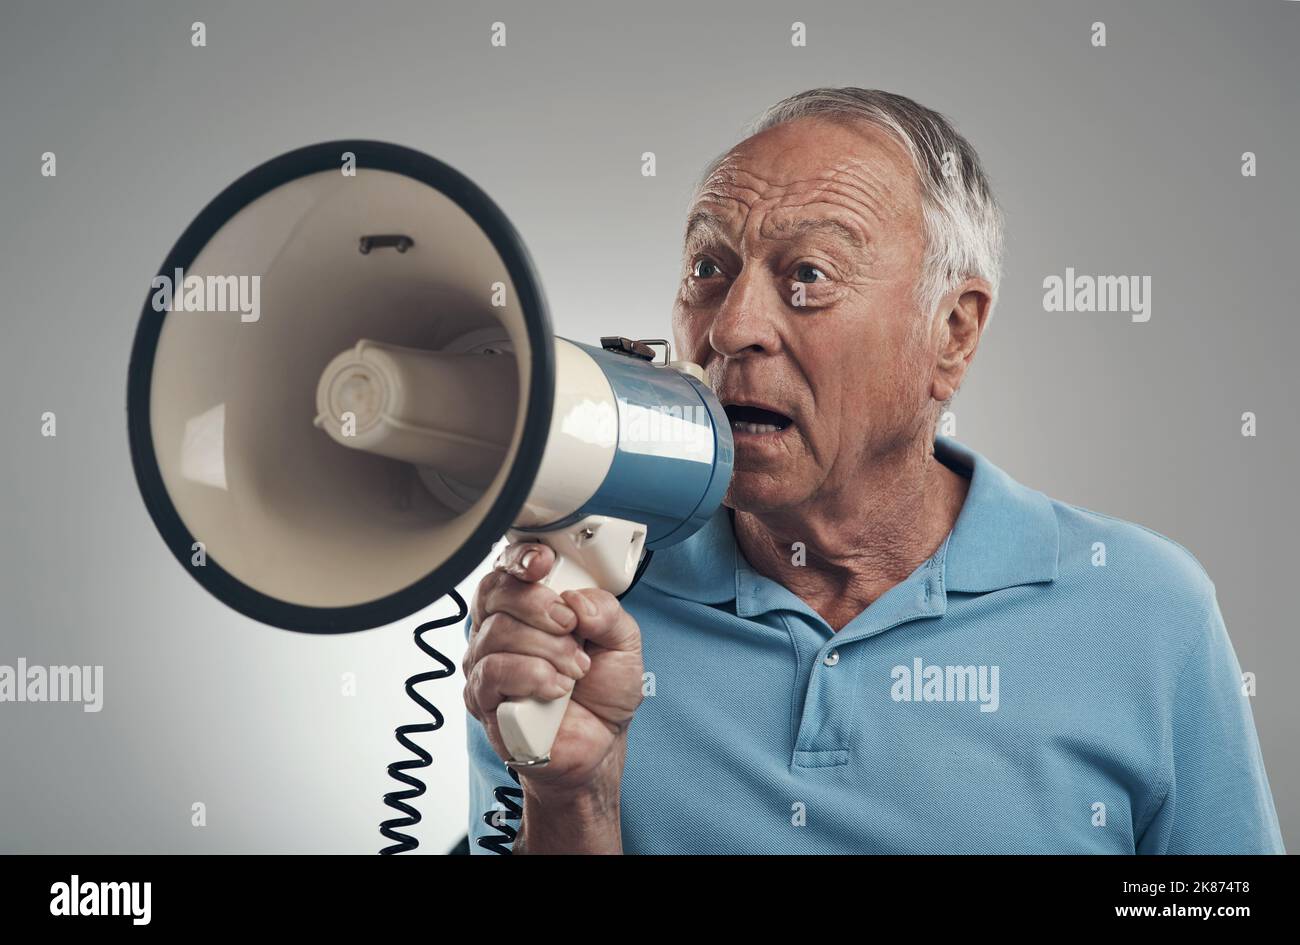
(1138, 594), (1284, 854)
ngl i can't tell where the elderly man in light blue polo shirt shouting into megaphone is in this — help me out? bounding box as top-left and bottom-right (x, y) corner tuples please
(464, 88), (1282, 854)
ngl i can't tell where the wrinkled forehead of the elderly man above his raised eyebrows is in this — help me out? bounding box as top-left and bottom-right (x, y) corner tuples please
(692, 118), (920, 222)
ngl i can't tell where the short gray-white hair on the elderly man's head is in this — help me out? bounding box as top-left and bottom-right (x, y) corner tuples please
(701, 87), (1002, 324)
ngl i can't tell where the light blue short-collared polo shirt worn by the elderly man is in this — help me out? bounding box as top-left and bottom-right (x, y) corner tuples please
(469, 437), (1283, 854)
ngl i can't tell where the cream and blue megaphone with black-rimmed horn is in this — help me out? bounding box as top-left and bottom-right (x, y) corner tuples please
(127, 140), (733, 766)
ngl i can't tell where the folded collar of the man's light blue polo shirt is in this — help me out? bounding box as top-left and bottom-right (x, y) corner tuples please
(641, 437), (1060, 604)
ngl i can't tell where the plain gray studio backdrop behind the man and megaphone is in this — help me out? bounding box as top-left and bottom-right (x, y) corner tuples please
(0, 0), (1300, 853)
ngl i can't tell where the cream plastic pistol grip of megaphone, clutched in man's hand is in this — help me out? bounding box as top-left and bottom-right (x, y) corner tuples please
(497, 515), (646, 767)
